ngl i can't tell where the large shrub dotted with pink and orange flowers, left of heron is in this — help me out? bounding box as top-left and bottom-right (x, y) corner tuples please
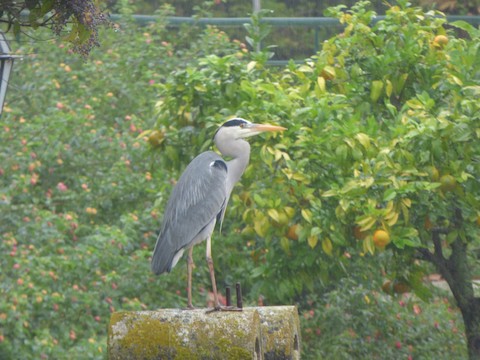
(0, 7), (246, 359)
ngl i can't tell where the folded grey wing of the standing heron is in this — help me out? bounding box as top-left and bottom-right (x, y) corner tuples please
(152, 151), (227, 274)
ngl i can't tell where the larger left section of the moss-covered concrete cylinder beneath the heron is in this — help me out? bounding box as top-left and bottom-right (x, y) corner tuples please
(108, 308), (263, 360)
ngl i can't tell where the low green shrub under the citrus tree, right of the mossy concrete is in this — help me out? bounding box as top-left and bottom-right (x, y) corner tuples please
(302, 279), (467, 359)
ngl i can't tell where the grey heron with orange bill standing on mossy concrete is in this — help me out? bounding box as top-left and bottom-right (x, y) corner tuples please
(151, 118), (286, 310)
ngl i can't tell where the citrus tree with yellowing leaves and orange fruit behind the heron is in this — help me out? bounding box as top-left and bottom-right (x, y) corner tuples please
(152, 1), (480, 358)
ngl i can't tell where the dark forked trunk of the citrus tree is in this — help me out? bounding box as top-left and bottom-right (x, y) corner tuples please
(420, 224), (480, 360)
